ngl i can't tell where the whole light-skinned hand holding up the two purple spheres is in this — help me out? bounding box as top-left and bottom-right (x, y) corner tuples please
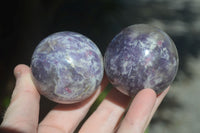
(0, 65), (169, 133)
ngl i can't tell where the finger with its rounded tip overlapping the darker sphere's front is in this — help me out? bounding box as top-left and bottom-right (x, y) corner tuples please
(118, 89), (156, 133)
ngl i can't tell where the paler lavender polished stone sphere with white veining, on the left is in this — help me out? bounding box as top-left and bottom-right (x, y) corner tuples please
(31, 31), (103, 103)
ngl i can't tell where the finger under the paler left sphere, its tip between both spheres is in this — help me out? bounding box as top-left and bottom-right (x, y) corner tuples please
(39, 76), (108, 133)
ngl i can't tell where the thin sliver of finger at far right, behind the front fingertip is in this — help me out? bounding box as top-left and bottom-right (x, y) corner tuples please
(145, 87), (170, 129)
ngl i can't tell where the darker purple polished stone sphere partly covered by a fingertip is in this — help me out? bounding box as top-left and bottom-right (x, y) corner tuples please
(104, 24), (179, 96)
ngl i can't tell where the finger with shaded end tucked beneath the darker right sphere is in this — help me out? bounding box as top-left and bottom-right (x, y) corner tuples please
(80, 89), (131, 133)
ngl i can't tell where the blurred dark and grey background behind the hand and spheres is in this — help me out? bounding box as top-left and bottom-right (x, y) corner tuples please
(0, 0), (200, 133)
